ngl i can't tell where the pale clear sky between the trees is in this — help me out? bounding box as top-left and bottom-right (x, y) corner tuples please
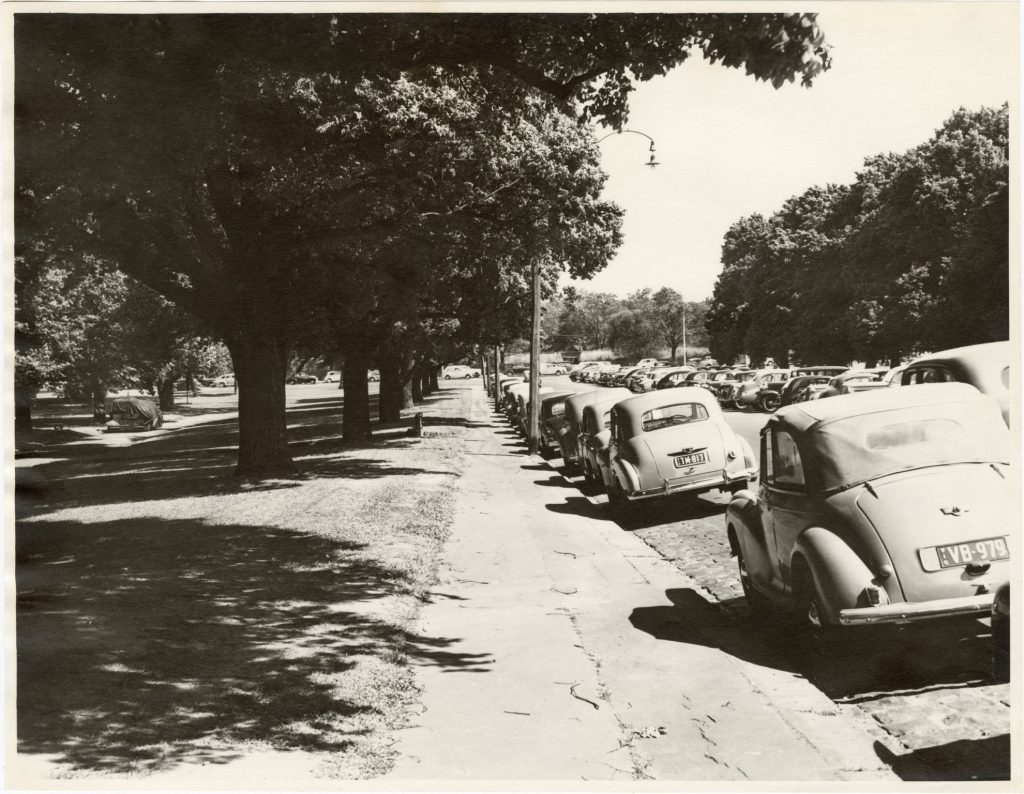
(562, 2), (1020, 300)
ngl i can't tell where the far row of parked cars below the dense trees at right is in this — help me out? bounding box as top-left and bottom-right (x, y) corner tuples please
(569, 342), (1010, 420)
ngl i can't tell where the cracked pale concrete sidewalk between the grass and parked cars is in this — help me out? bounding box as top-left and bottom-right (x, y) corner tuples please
(385, 391), (897, 783)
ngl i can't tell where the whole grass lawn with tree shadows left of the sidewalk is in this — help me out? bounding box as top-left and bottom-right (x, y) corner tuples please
(15, 382), (471, 785)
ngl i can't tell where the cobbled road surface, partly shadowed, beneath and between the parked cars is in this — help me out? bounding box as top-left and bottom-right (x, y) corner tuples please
(532, 377), (1012, 780)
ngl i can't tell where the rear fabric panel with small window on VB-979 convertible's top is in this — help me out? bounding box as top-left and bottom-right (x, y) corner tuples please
(808, 402), (1010, 491)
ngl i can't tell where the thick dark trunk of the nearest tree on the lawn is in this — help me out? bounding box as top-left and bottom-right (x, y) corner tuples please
(228, 324), (296, 477)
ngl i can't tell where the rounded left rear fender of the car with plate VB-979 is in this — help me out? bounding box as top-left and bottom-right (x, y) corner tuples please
(791, 527), (873, 624)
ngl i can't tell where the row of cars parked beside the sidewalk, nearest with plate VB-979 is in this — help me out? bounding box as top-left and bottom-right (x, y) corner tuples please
(499, 344), (1020, 680)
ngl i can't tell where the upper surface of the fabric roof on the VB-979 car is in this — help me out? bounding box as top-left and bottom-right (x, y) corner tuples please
(765, 383), (990, 431)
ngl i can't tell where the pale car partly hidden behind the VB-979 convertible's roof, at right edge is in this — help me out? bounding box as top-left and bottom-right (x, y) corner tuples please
(900, 342), (1015, 427)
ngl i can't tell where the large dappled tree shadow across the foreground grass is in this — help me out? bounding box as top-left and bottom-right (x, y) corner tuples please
(15, 517), (485, 772)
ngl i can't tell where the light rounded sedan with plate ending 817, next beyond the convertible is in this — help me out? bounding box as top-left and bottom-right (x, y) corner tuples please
(605, 386), (758, 504)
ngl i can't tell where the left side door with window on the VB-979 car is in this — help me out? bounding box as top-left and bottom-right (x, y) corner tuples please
(762, 427), (815, 587)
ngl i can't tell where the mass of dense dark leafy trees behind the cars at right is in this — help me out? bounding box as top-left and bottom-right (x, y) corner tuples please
(707, 105), (1010, 365)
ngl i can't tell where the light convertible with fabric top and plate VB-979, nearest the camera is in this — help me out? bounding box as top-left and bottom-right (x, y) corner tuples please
(726, 383), (1007, 629)
